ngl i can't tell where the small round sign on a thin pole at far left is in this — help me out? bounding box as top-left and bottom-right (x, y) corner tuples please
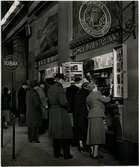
(3, 55), (19, 71)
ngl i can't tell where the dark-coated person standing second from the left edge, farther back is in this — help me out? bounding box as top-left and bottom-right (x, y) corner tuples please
(18, 83), (28, 126)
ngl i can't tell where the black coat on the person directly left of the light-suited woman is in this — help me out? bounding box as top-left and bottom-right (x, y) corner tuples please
(74, 89), (89, 140)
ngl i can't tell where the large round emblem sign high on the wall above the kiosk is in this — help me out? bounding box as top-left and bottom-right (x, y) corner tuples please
(79, 1), (111, 37)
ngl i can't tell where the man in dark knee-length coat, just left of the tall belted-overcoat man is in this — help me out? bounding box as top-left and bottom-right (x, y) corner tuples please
(26, 82), (42, 143)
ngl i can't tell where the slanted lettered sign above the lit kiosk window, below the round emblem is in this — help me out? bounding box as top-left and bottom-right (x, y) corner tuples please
(73, 32), (119, 56)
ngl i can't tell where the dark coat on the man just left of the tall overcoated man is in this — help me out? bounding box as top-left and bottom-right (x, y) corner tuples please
(26, 89), (42, 127)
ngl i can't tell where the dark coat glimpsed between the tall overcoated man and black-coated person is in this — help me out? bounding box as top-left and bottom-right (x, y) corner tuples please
(66, 85), (79, 112)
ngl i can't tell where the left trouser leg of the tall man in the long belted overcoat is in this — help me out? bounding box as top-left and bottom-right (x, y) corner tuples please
(53, 139), (61, 158)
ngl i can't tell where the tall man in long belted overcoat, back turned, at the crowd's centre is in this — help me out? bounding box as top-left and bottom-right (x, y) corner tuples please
(48, 74), (73, 159)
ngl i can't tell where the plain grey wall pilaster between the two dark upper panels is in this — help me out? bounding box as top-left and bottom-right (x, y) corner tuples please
(58, 1), (72, 63)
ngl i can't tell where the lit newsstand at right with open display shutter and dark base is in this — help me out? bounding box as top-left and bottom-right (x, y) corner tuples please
(85, 45), (128, 152)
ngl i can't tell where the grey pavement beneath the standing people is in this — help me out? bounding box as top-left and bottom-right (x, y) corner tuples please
(1, 122), (120, 166)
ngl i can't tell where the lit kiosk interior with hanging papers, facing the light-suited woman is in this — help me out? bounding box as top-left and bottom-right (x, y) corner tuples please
(92, 52), (113, 95)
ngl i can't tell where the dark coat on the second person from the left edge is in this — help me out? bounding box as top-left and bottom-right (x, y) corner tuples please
(18, 87), (26, 115)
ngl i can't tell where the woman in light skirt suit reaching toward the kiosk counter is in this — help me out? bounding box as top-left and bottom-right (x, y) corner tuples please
(86, 83), (110, 158)
